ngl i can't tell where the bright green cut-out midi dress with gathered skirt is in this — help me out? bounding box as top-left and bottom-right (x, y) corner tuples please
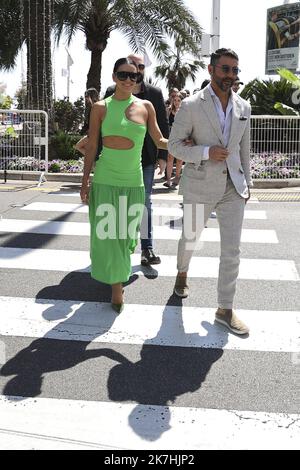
(89, 95), (147, 284)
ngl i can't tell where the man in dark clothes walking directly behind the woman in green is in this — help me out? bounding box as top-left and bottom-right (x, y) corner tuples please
(104, 54), (169, 266)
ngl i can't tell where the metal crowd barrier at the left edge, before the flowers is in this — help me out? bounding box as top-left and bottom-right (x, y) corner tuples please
(0, 109), (48, 184)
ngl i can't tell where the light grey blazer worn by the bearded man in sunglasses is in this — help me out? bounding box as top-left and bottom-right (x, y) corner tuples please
(168, 88), (252, 203)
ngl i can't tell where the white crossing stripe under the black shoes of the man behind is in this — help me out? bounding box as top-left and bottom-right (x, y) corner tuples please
(0, 247), (300, 281)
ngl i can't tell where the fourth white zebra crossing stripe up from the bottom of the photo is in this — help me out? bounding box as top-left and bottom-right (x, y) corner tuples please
(0, 219), (279, 243)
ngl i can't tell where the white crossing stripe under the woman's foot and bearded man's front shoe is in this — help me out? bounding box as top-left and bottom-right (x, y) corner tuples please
(0, 297), (300, 353)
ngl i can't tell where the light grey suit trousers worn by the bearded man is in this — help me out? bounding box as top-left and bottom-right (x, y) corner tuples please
(177, 177), (245, 309)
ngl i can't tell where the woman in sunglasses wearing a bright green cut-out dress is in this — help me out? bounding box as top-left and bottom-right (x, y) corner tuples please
(80, 58), (168, 313)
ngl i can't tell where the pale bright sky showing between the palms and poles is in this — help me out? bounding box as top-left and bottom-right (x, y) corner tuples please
(0, 0), (292, 100)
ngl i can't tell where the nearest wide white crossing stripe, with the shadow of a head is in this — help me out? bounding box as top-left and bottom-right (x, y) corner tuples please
(0, 395), (300, 450)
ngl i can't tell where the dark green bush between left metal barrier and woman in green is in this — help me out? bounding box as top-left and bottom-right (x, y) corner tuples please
(49, 130), (81, 160)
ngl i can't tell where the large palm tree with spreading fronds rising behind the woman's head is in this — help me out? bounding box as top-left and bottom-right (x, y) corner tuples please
(54, 0), (201, 91)
